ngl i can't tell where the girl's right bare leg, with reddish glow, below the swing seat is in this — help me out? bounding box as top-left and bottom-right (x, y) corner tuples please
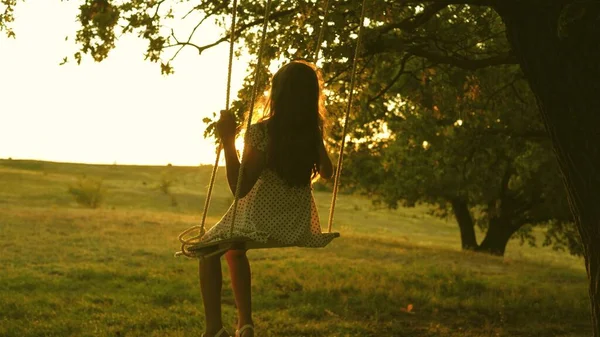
(225, 250), (254, 337)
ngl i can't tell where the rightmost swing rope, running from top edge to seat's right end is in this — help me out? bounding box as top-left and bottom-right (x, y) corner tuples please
(327, 0), (367, 233)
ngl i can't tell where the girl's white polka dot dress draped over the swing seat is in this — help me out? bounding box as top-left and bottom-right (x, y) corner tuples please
(201, 123), (337, 247)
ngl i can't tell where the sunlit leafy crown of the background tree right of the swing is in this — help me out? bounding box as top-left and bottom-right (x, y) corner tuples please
(346, 58), (580, 253)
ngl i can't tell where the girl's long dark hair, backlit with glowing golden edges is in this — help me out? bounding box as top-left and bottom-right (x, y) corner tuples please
(266, 61), (325, 186)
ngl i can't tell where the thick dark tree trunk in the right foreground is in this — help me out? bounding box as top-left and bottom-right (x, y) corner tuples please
(496, 0), (600, 337)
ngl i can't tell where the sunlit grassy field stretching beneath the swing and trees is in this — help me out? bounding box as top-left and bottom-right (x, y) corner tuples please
(0, 160), (591, 337)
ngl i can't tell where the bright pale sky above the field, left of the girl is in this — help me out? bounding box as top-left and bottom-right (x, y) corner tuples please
(0, 0), (249, 166)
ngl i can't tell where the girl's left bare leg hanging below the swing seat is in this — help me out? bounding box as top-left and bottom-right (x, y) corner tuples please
(199, 254), (223, 336)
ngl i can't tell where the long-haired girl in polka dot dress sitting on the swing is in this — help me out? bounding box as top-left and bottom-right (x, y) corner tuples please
(200, 61), (337, 337)
